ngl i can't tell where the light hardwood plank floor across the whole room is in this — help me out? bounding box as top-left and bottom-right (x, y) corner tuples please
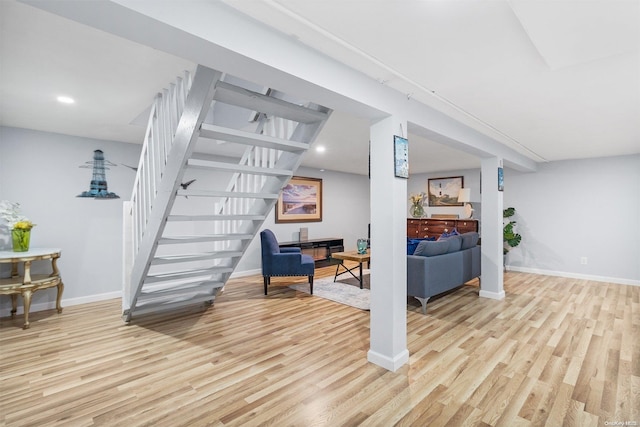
(0, 267), (640, 427)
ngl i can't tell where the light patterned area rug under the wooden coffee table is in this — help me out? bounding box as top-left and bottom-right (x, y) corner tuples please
(289, 273), (369, 310)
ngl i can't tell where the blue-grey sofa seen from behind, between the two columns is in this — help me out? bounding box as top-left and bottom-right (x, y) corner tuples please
(407, 232), (480, 314)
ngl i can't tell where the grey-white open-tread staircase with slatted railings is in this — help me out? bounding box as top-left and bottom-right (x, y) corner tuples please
(122, 66), (331, 322)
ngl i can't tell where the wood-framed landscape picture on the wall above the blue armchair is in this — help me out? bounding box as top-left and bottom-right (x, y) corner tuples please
(276, 176), (322, 223)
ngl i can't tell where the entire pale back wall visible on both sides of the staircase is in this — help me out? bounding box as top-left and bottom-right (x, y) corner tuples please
(0, 127), (369, 316)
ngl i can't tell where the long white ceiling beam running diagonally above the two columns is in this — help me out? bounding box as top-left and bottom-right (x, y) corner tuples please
(24, 0), (536, 174)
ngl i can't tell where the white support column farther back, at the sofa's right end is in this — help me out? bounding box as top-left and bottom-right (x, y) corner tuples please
(480, 157), (505, 300)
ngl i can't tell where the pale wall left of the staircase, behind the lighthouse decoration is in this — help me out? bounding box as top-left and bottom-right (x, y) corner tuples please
(0, 127), (141, 312)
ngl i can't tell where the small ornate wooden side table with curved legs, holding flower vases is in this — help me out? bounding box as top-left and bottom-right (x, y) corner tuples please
(0, 248), (64, 329)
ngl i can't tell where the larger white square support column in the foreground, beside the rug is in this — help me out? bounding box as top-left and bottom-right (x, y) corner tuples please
(367, 116), (411, 371)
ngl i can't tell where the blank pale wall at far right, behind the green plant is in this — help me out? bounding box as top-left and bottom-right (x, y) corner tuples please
(504, 154), (640, 285)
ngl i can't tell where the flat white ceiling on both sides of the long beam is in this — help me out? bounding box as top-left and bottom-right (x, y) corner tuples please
(0, 0), (640, 174)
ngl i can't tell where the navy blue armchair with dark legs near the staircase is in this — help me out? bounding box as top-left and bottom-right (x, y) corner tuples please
(260, 229), (315, 295)
